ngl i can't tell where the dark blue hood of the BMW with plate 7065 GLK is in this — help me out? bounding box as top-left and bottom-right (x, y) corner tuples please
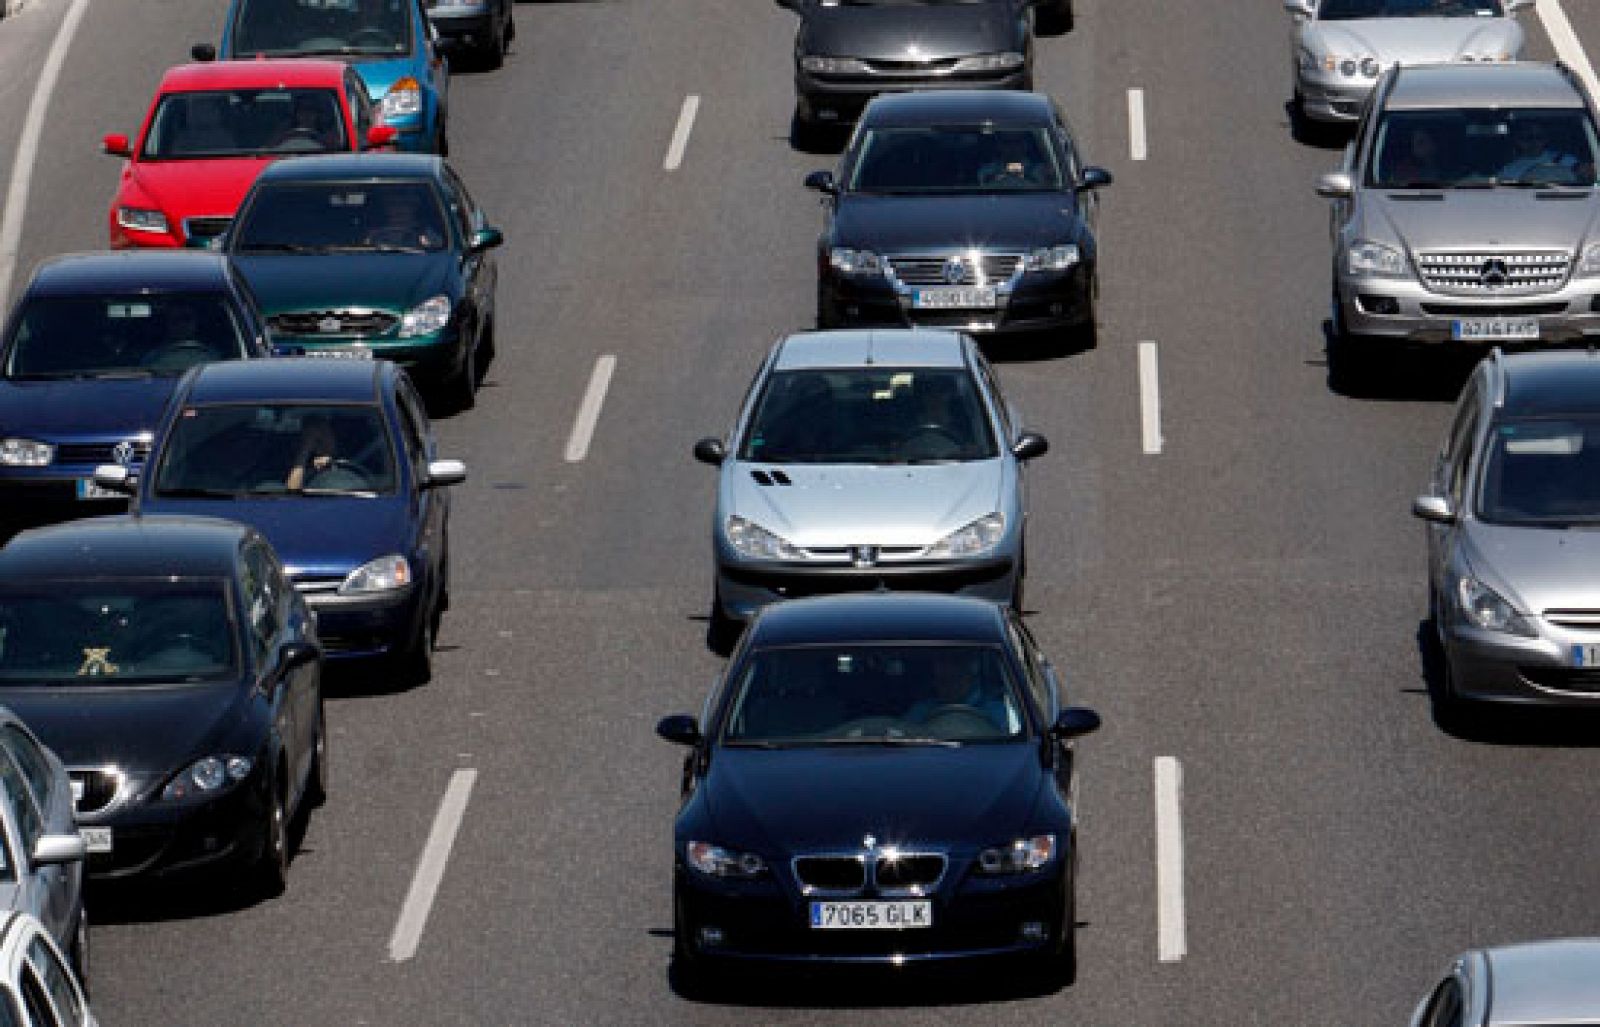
(701, 744), (1042, 853)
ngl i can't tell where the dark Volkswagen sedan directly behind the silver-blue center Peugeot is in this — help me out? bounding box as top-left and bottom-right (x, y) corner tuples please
(806, 91), (1110, 349)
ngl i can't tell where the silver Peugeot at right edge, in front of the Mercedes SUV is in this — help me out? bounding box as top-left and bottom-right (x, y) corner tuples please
(1413, 350), (1600, 725)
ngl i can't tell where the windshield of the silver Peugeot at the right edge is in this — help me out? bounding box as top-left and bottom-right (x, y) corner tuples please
(1478, 416), (1600, 526)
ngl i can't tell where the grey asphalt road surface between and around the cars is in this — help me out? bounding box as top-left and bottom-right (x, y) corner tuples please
(0, 0), (1600, 1025)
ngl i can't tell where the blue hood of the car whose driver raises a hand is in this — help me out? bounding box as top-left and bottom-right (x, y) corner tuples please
(139, 496), (410, 577)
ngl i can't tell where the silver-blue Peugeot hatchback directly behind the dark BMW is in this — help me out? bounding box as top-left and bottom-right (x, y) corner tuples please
(694, 330), (1048, 629)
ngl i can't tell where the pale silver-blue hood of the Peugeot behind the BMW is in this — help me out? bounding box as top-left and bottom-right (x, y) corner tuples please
(723, 459), (1005, 547)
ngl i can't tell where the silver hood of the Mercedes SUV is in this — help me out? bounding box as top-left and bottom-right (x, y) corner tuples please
(1365, 189), (1600, 253)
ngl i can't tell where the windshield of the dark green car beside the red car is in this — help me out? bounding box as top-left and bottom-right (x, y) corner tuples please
(232, 181), (448, 253)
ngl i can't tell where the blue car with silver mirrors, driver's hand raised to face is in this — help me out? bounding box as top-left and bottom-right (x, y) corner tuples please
(96, 357), (467, 681)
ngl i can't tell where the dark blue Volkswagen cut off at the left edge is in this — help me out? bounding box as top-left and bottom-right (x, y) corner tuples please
(0, 251), (269, 528)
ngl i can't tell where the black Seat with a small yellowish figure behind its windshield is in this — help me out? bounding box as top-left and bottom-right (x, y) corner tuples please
(0, 515), (328, 894)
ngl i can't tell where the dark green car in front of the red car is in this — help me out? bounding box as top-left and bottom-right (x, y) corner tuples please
(226, 154), (502, 410)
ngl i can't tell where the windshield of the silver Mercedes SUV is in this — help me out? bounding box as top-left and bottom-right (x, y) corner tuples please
(1368, 107), (1597, 189)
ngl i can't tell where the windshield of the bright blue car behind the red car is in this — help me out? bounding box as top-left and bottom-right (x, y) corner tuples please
(230, 0), (414, 58)
